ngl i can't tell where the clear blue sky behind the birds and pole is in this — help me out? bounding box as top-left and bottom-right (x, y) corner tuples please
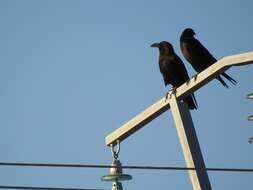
(0, 0), (253, 190)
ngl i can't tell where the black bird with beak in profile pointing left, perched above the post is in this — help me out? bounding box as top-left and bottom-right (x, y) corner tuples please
(151, 41), (197, 109)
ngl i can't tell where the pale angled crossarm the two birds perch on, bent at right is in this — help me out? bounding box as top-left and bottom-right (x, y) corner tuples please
(106, 52), (253, 146)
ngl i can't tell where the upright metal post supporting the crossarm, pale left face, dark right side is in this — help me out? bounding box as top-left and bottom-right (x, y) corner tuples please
(170, 93), (212, 190)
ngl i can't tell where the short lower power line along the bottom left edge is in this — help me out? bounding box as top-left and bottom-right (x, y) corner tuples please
(0, 185), (105, 190)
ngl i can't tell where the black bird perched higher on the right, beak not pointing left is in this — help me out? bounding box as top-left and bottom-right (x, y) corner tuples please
(180, 28), (237, 88)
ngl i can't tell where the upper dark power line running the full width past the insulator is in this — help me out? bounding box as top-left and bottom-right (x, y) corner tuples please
(0, 162), (253, 172)
